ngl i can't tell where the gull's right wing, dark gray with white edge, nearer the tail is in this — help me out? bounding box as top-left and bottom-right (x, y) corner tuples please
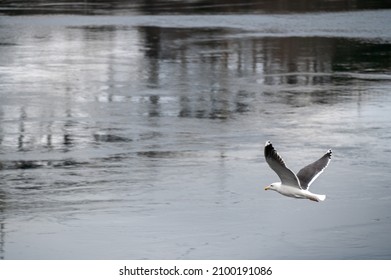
(297, 150), (332, 190)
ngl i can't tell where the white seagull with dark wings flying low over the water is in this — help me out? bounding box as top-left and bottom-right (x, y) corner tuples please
(265, 141), (332, 202)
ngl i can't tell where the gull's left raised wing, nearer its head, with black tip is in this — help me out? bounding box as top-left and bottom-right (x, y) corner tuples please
(265, 141), (301, 188)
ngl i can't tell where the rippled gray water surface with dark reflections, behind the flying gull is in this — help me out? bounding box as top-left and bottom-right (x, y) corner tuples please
(0, 1), (391, 259)
